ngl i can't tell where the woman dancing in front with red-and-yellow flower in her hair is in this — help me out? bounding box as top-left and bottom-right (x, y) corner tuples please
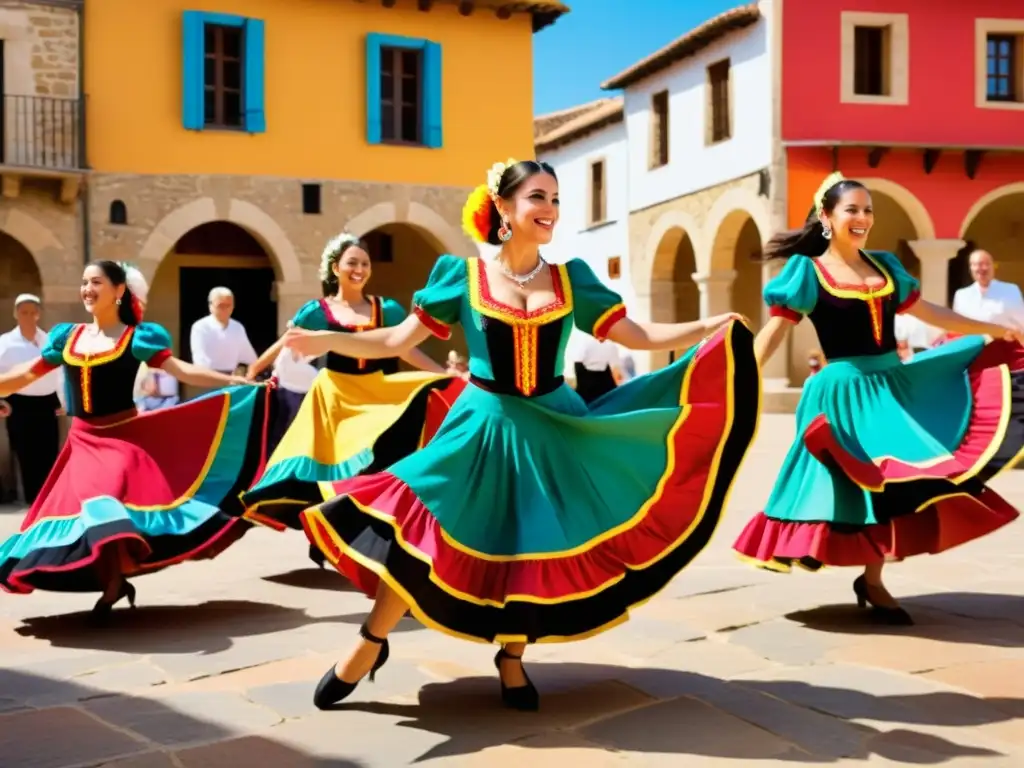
(286, 161), (760, 710)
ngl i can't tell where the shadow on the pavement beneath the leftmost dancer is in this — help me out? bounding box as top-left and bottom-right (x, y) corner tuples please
(12, 600), (420, 655)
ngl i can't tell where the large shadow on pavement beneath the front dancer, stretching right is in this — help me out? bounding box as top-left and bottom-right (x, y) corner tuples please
(336, 663), (1024, 765)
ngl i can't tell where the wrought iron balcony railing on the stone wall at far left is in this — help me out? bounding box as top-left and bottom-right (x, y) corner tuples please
(0, 95), (85, 171)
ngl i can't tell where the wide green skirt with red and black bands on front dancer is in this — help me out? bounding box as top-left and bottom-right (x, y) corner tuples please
(302, 324), (760, 642)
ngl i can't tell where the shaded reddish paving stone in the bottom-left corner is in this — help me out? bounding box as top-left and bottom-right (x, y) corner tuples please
(0, 707), (150, 768)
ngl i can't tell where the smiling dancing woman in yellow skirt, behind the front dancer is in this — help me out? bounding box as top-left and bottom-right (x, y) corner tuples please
(243, 233), (462, 565)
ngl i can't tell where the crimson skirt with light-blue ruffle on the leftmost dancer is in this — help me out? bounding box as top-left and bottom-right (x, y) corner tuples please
(0, 386), (270, 593)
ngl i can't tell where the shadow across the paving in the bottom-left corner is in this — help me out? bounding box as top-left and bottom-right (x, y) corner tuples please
(0, 670), (364, 768)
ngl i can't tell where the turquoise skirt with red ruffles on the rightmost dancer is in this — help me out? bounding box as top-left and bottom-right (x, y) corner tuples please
(735, 336), (1024, 571)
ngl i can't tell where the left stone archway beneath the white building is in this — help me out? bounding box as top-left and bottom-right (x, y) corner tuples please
(650, 226), (700, 370)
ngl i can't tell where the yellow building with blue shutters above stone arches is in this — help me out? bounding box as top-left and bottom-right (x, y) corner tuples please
(0, 0), (568, 499)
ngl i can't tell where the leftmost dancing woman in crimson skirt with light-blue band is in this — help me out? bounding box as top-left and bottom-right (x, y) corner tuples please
(0, 261), (267, 617)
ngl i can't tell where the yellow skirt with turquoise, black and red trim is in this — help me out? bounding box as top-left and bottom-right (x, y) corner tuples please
(242, 370), (465, 530)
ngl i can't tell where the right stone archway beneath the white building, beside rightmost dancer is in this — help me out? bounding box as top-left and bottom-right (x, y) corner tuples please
(710, 210), (763, 323)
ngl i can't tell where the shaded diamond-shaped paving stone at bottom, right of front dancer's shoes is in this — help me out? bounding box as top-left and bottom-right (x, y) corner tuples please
(580, 698), (792, 765)
